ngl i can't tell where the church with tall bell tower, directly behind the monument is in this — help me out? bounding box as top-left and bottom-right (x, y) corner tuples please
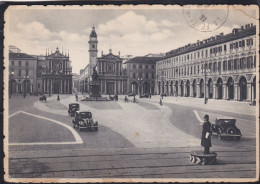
(80, 27), (127, 95)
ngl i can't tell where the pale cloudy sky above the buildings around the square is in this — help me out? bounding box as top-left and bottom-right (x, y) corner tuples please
(5, 6), (257, 74)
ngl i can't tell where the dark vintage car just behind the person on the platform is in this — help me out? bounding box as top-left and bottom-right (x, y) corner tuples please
(212, 119), (242, 140)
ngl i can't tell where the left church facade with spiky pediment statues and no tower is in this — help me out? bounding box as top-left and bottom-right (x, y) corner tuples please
(41, 47), (72, 94)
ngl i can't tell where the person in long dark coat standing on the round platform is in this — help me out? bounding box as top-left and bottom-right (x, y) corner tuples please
(201, 114), (211, 154)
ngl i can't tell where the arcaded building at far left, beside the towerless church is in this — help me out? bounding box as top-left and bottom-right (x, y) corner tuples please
(9, 50), (37, 95)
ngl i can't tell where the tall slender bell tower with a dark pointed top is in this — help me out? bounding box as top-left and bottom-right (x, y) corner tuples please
(88, 26), (98, 75)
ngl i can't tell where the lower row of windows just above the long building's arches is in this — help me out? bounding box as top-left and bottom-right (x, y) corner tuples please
(161, 56), (256, 77)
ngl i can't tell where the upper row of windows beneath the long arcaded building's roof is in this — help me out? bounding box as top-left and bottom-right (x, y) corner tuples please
(157, 38), (254, 65)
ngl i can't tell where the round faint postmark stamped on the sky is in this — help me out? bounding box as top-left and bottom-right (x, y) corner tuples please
(183, 6), (229, 32)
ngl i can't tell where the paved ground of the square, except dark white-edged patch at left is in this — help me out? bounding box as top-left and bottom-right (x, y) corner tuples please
(6, 95), (256, 181)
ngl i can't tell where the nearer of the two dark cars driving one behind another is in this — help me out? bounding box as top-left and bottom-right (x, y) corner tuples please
(72, 111), (98, 131)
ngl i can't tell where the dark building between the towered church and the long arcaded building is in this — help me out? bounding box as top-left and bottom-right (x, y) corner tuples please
(126, 56), (162, 95)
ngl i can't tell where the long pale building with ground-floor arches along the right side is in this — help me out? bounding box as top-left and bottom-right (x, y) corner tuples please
(156, 24), (257, 101)
